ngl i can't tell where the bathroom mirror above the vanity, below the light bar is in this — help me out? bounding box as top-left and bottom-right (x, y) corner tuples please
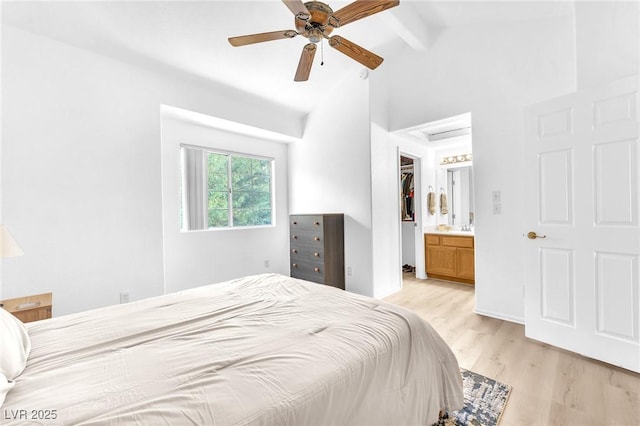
(447, 166), (475, 226)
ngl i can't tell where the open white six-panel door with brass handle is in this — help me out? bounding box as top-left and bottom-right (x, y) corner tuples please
(523, 76), (640, 372)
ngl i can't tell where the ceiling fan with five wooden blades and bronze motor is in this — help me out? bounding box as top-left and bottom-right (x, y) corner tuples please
(229, 0), (400, 81)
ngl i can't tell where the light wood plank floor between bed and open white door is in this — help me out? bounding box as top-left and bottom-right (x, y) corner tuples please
(385, 274), (640, 426)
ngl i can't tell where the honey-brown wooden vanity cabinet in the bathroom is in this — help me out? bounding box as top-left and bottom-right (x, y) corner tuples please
(424, 234), (475, 284)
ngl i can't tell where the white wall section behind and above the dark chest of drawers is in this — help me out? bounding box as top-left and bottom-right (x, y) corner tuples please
(289, 73), (372, 296)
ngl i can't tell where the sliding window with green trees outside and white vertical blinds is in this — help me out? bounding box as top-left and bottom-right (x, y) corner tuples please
(180, 145), (274, 231)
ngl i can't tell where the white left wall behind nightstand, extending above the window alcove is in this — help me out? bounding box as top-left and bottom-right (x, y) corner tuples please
(1, 25), (302, 315)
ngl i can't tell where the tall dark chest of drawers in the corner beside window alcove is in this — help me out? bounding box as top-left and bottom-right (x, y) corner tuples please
(289, 214), (345, 290)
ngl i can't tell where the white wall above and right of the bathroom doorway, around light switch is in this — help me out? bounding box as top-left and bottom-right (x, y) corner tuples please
(374, 18), (575, 320)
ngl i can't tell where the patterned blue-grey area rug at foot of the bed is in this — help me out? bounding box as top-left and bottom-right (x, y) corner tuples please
(434, 368), (511, 426)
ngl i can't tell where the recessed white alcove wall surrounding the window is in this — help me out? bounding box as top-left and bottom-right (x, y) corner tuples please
(162, 113), (289, 292)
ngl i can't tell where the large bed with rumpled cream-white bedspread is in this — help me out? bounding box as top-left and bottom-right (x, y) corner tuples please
(0, 274), (463, 426)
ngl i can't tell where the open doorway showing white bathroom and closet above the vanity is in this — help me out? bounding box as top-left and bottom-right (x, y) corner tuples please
(393, 112), (475, 286)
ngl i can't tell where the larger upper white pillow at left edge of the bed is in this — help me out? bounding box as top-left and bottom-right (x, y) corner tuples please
(0, 308), (31, 385)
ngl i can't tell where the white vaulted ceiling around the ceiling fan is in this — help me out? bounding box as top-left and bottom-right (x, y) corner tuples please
(2, 0), (573, 112)
